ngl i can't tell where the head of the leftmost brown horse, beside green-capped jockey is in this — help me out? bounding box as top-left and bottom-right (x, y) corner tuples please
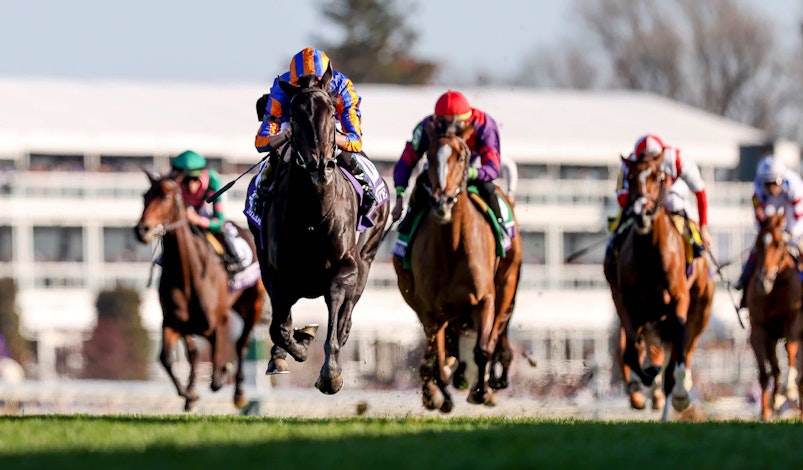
(134, 168), (187, 243)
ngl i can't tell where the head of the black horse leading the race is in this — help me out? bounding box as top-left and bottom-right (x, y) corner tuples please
(279, 68), (336, 186)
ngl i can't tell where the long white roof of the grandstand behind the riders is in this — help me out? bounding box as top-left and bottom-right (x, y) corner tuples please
(0, 78), (784, 167)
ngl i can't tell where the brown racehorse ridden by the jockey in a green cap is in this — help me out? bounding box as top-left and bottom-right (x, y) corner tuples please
(134, 170), (266, 411)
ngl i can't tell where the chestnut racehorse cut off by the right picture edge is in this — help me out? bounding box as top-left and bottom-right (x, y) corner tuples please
(747, 208), (803, 421)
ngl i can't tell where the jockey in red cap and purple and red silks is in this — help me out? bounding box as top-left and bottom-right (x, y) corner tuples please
(392, 90), (508, 242)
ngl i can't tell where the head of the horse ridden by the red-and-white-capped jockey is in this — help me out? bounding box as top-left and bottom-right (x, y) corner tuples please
(622, 155), (667, 234)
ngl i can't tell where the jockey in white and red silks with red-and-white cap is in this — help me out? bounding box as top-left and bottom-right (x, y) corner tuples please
(606, 134), (711, 258)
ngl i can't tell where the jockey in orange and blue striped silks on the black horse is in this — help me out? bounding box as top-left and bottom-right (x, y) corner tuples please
(254, 47), (376, 214)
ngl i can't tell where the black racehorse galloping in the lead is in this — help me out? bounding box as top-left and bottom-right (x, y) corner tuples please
(250, 69), (389, 394)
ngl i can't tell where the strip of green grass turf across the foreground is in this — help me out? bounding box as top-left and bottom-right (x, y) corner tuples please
(0, 415), (803, 470)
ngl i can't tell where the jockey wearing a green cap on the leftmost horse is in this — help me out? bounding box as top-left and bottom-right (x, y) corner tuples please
(171, 150), (244, 274)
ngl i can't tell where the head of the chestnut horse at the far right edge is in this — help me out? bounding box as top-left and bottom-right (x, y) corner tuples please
(756, 206), (794, 294)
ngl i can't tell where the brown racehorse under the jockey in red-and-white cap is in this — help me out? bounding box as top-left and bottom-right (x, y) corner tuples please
(604, 157), (715, 421)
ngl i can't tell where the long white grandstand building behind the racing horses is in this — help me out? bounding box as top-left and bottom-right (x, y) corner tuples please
(0, 79), (800, 386)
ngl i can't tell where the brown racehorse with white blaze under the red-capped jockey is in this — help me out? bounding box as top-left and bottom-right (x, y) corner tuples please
(393, 120), (522, 413)
